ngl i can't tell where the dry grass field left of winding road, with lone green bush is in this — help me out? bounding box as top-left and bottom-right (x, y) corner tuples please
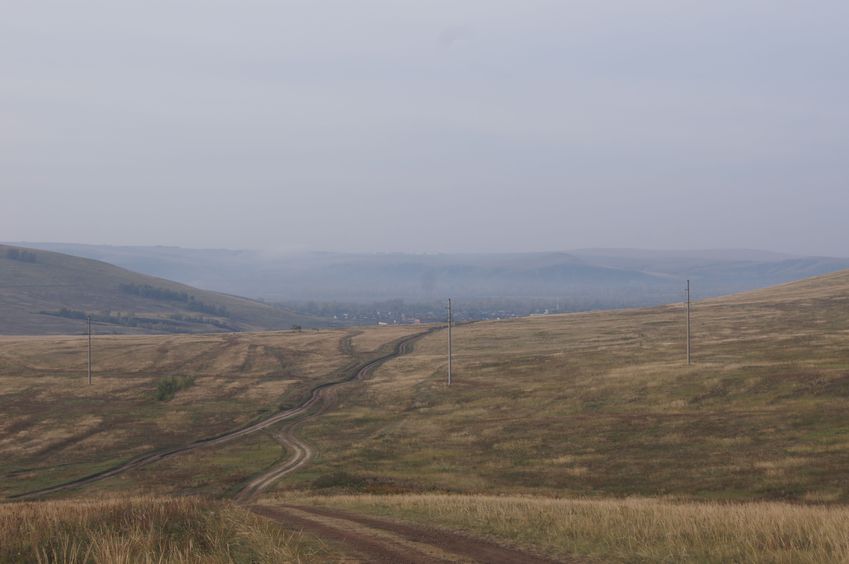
(0, 327), (420, 496)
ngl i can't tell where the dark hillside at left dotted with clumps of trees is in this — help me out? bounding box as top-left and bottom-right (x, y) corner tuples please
(0, 245), (319, 334)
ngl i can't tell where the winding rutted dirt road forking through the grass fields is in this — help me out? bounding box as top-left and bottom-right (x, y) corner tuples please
(12, 329), (568, 564)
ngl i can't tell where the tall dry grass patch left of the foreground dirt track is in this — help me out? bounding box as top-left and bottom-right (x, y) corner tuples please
(0, 497), (335, 564)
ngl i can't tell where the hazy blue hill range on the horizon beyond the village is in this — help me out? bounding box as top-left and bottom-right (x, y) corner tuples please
(14, 243), (849, 311)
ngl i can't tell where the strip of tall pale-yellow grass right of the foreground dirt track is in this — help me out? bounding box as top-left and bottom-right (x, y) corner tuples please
(276, 494), (849, 564)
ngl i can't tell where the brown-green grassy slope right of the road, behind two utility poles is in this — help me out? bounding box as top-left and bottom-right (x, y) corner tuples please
(281, 273), (849, 503)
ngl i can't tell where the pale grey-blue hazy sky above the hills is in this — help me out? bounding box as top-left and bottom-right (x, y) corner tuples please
(0, 0), (849, 256)
